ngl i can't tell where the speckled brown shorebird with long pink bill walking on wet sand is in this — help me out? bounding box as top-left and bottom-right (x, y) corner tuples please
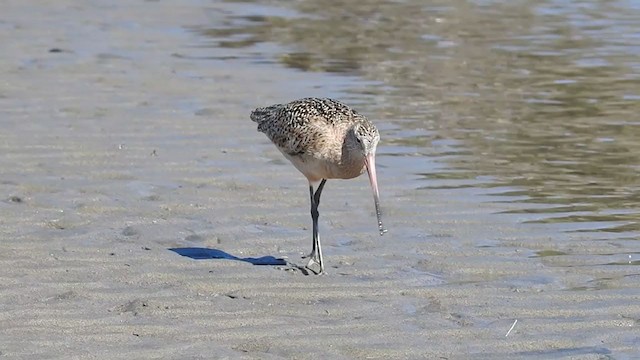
(251, 98), (387, 274)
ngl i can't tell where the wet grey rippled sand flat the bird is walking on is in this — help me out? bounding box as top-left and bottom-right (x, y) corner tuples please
(0, 0), (640, 359)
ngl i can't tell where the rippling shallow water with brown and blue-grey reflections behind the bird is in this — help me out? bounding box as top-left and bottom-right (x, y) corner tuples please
(196, 0), (640, 282)
